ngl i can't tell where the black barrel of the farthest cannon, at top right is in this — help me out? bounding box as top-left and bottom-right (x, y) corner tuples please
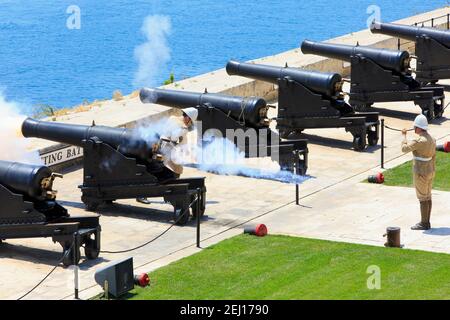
(370, 21), (450, 48)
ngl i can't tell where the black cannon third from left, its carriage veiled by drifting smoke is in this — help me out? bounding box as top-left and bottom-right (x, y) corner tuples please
(140, 88), (308, 175)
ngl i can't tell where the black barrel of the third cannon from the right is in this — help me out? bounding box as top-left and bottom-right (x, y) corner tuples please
(226, 60), (342, 96)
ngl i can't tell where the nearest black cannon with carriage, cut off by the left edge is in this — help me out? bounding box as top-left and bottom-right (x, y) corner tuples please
(0, 161), (101, 266)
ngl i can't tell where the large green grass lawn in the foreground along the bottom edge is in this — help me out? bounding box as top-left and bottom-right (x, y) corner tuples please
(115, 235), (450, 300)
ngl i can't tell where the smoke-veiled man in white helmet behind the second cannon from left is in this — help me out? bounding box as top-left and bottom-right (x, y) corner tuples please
(136, 108), (198, 204)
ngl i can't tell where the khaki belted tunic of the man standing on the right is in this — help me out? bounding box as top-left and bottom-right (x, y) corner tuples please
(402, 132), (436, 176)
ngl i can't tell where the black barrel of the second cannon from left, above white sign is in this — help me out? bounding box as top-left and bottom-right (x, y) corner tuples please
(22, 118), (152, 160)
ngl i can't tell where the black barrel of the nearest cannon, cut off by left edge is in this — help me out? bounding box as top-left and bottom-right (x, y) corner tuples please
(0, 160), (52, 200)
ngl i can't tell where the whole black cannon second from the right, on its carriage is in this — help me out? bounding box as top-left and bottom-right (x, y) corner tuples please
(301, 40), (444, 120)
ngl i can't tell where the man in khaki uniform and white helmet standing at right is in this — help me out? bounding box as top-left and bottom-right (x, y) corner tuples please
(402, 115), (436, 230)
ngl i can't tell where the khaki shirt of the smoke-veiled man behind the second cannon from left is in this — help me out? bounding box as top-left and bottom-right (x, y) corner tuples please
(161, 116), (189, 175)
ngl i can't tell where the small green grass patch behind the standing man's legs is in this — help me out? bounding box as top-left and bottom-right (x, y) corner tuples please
(383, 152), (450, 191)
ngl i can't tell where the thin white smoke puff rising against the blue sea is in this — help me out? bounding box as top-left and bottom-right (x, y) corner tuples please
(133, 15), (172, 87)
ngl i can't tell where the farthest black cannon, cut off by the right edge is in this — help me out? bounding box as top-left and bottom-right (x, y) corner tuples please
(370, 21), (450, 84)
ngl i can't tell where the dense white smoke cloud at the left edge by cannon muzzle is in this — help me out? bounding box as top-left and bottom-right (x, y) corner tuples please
(0, 90), (42, 164)
